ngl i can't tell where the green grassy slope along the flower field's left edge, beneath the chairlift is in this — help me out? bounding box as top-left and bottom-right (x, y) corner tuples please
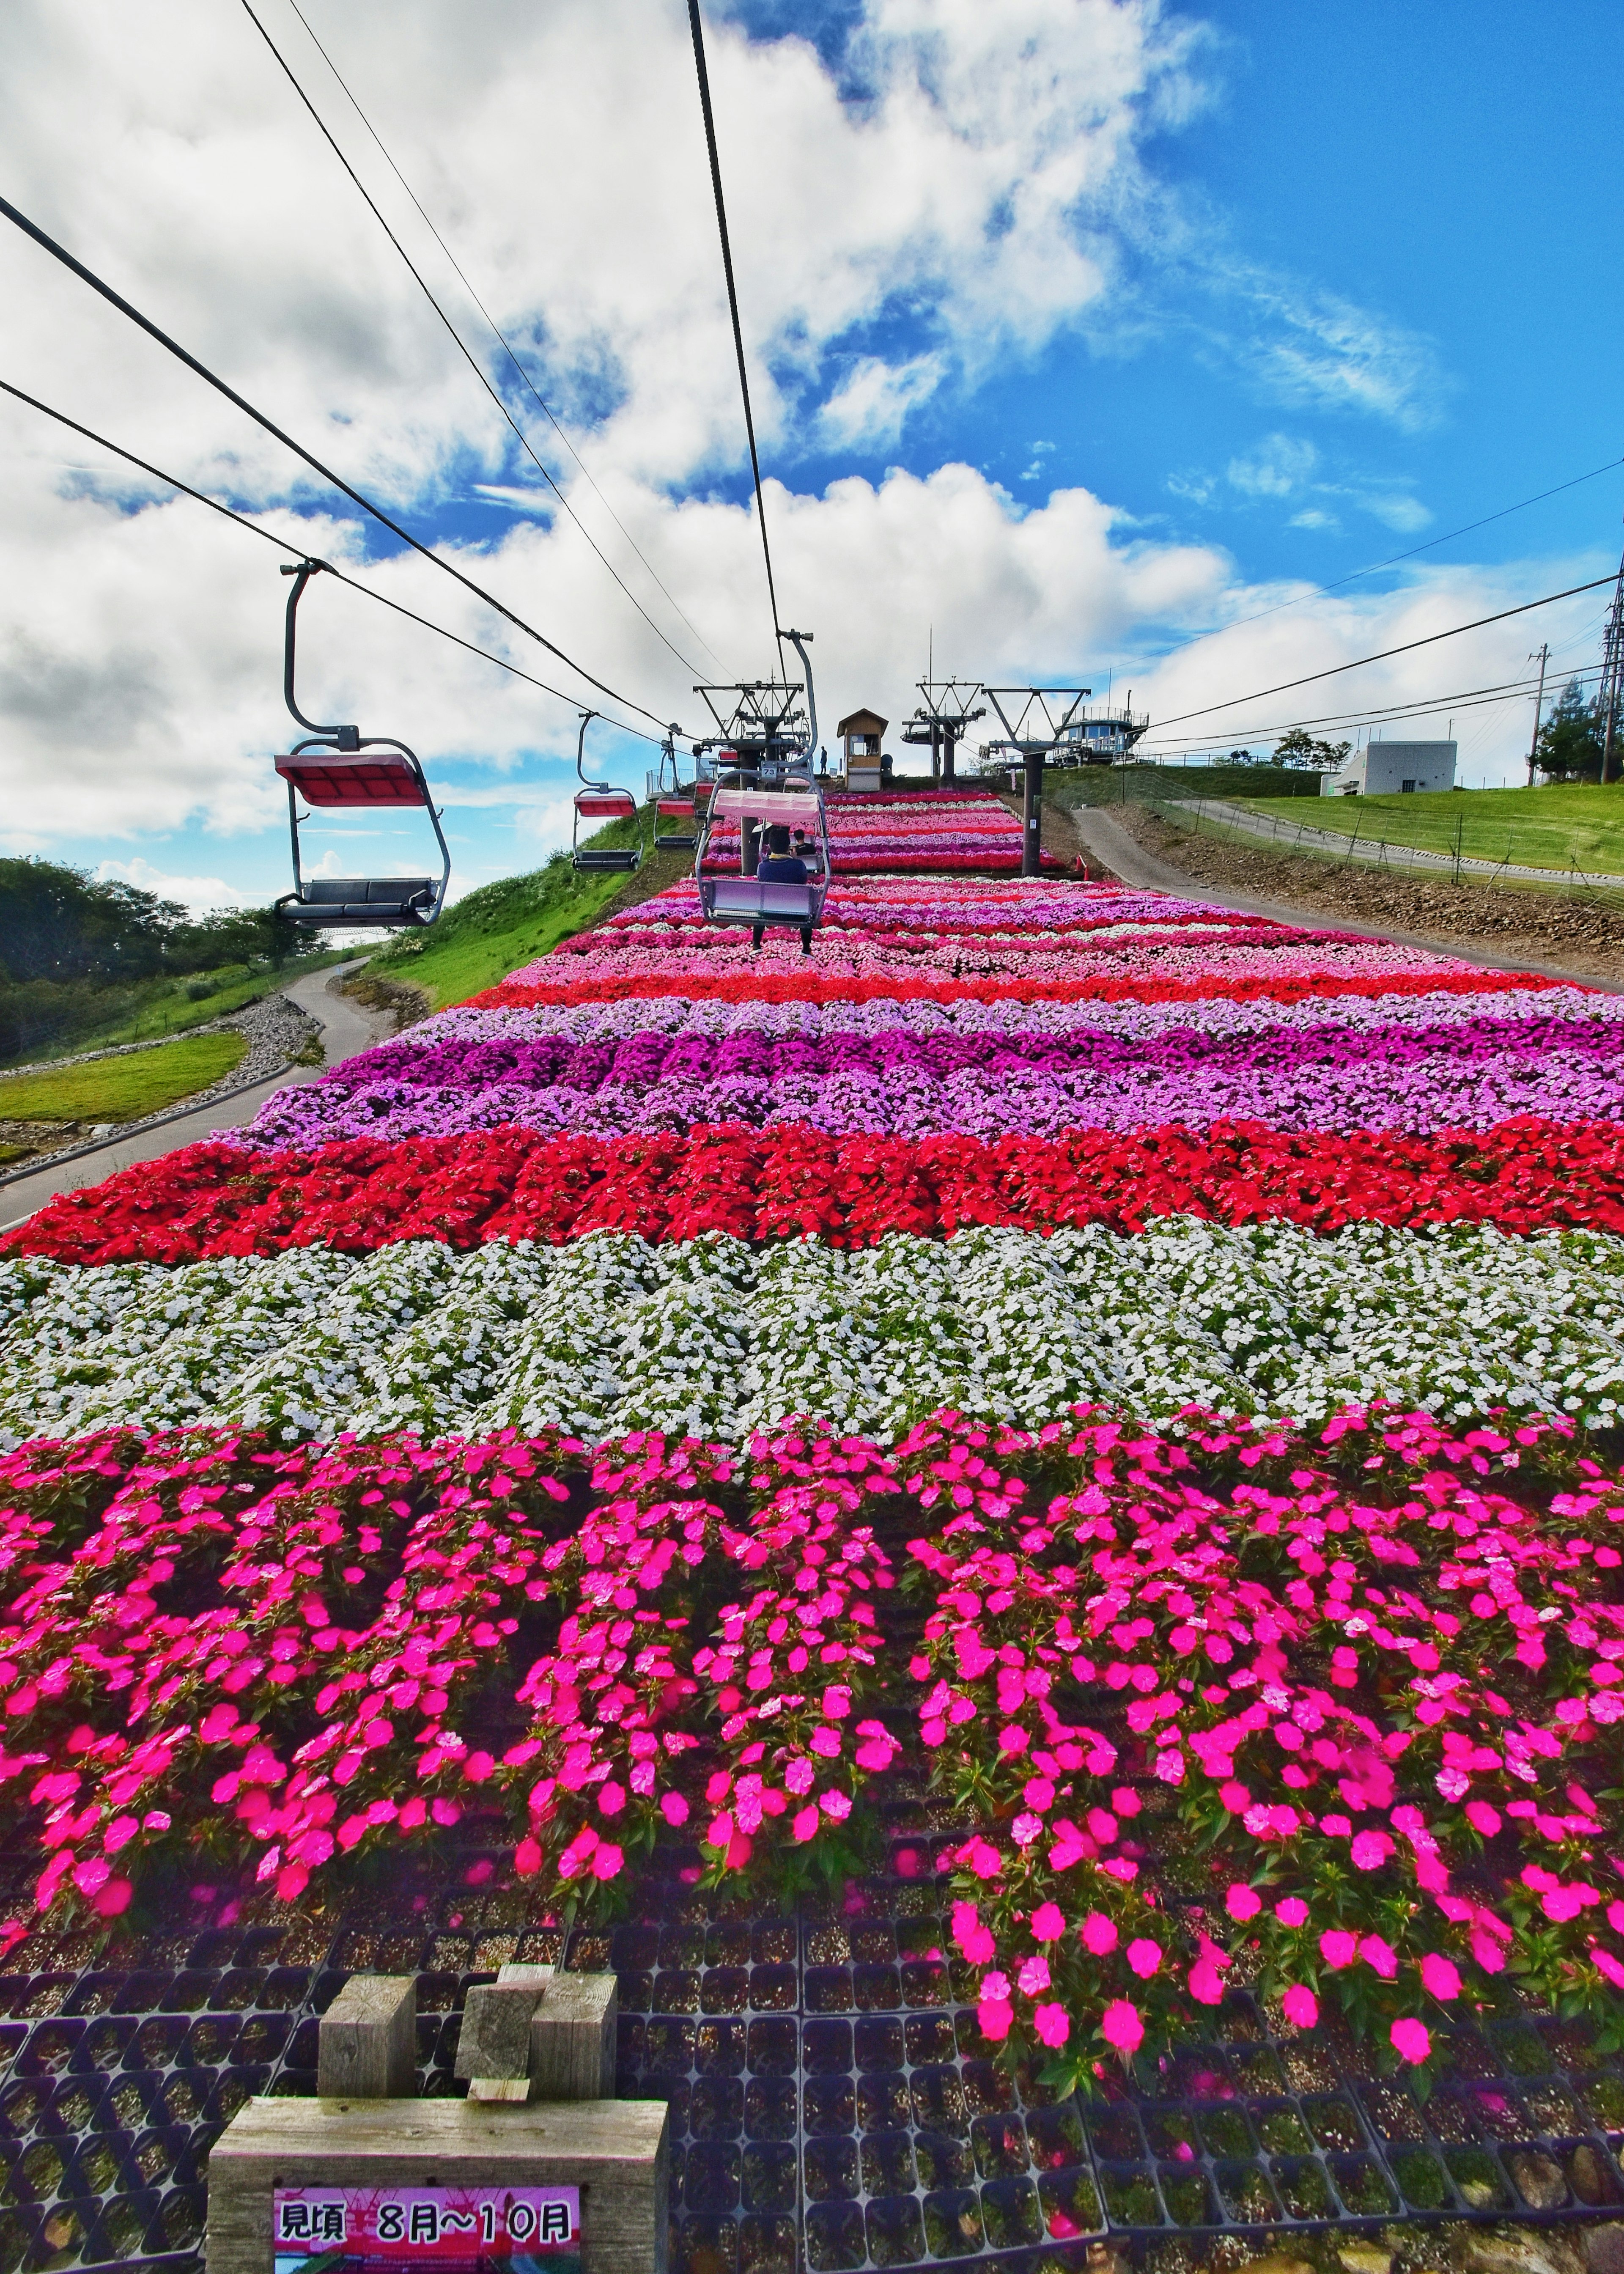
(368, 821), (694, 1010)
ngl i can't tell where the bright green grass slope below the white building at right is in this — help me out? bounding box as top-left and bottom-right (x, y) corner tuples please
(1215, 782), (1624, 876)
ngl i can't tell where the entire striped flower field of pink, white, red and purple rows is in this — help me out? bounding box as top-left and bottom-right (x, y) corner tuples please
(0, 798), (1624, 2265)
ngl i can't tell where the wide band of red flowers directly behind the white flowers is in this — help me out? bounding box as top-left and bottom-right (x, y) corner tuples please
(16, 1117), (1624, 1264)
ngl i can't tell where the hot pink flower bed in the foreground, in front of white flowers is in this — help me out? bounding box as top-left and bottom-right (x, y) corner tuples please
(0, 1412), (1624, 2085)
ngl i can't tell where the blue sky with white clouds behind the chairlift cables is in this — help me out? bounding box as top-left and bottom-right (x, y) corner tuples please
(0, 0), (1624, 923)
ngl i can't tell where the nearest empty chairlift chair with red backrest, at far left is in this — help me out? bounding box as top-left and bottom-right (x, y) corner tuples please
(275, 562), (450, 932)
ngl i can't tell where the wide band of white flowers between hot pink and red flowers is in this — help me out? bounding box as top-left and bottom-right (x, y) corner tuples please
(0, 1217), (1624, 1444)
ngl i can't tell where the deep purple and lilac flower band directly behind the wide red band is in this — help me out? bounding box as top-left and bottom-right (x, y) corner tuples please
(234, 1016), (1624, 1144)
